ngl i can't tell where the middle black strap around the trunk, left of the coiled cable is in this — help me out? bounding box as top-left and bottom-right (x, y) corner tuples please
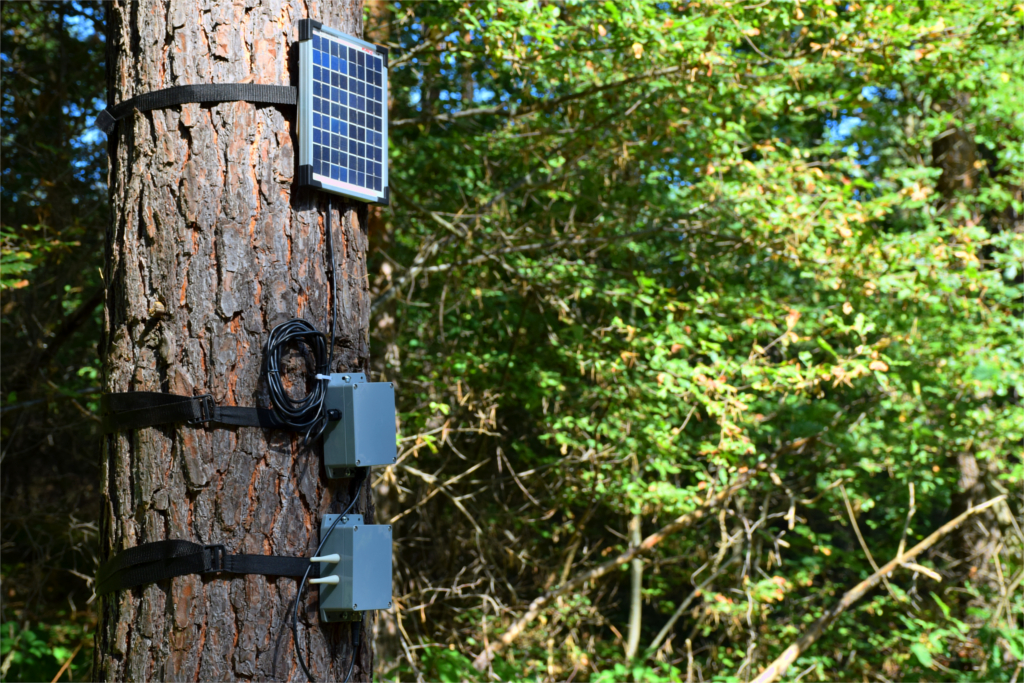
(102, 391), (287, 433)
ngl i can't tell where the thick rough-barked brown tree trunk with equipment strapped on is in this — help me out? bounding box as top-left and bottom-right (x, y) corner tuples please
(94, 0), (373, 681)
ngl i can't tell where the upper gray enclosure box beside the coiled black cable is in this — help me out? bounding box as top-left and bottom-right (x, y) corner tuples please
(324, 373), (398, 478)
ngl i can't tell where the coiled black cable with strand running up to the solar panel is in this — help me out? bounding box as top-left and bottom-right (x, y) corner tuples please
(263, 200), (338, 444)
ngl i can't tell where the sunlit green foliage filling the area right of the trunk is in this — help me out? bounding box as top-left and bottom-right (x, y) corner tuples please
(369, 1), (1024, 680)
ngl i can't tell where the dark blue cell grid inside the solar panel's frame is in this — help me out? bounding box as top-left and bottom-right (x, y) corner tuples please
(311, 31), (386, 193)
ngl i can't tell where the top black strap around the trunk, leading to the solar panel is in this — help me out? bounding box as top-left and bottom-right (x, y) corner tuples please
(96, 83), (298, 134)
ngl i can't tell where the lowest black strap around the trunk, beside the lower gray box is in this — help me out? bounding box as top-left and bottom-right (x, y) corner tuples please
(96, 541), (319, 595)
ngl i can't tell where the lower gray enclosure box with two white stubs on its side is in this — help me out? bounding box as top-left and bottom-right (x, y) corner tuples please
(319, 515), (391, 622)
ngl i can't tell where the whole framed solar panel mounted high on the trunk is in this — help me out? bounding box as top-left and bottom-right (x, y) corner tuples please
(298, 19), (388, 204)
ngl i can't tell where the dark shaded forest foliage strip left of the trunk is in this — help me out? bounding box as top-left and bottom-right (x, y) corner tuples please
(0, 2), (109, 681)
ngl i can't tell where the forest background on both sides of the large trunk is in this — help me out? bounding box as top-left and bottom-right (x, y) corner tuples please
(0, 0), (1024, 681)
